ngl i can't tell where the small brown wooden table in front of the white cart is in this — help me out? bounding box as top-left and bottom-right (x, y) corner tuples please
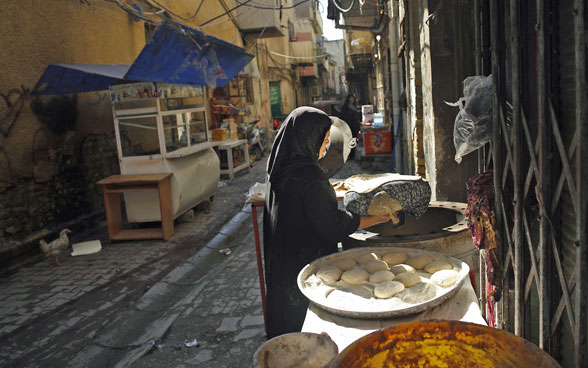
(98, 173), (174, 241)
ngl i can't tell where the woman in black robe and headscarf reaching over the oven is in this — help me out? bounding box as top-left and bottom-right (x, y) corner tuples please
(263, 107), (389, 338)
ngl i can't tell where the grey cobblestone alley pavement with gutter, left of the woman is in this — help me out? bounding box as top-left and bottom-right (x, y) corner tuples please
(0, 153), (372, 367)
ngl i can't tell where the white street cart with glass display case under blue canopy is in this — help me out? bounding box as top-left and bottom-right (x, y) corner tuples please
(110, 82), (220, 222)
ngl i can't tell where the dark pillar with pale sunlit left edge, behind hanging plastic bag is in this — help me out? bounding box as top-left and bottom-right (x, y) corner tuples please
(420, 0), (477, 202)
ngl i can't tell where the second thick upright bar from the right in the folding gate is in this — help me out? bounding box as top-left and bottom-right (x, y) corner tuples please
(531, 0), (551, 350)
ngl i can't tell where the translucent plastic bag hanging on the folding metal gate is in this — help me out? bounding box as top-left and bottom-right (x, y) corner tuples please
(446, 75), (492, 164)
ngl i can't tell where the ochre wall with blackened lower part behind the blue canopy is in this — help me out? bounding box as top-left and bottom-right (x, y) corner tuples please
(0, 0), (261, 263)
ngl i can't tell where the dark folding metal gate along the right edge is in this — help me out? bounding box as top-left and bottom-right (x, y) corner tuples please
(475, 0), (588, 367)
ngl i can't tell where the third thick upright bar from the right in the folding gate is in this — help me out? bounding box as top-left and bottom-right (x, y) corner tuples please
(510, 1), (523, 336)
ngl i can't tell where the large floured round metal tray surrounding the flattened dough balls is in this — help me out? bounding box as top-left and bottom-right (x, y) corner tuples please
(297, 247), (470, 319)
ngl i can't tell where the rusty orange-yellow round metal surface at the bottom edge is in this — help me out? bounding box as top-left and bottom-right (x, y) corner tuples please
(331, 321), (559, 368)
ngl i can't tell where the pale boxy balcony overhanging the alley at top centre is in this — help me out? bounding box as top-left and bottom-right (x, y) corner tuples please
(237, 0), (288, 38)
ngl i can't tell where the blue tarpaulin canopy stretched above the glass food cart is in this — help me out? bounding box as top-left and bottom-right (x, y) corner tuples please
(33, 20), (253, 94)
